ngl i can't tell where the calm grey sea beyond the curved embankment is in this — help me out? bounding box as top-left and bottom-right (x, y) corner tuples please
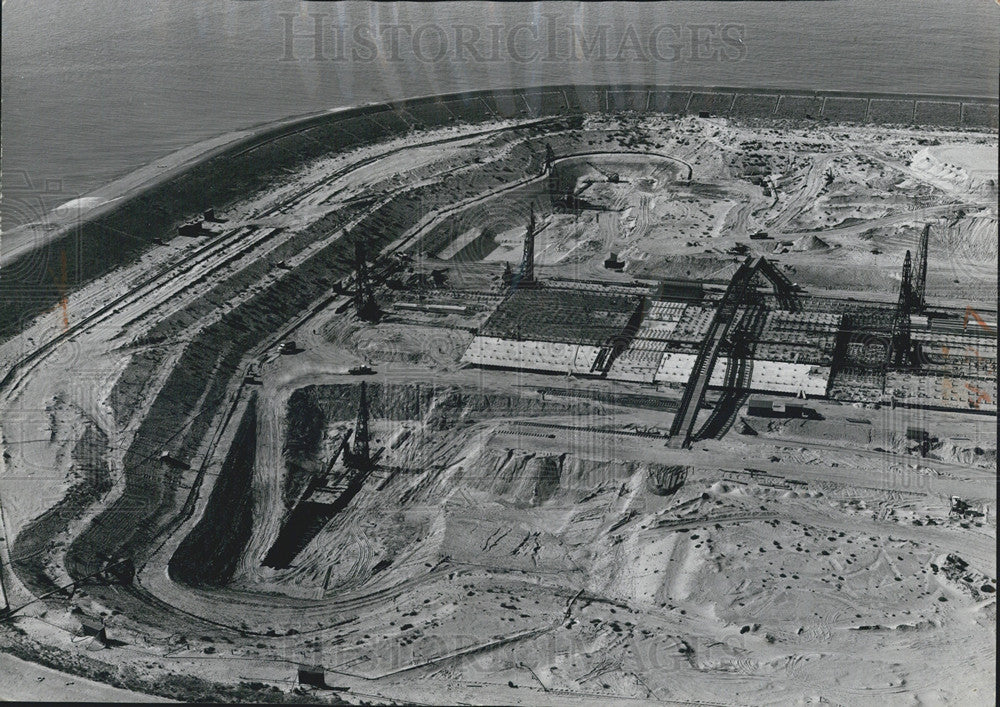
(2, 0), (1000, 230)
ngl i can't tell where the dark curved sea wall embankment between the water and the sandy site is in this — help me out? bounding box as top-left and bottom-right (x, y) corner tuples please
(0, 85), (998, 339)
